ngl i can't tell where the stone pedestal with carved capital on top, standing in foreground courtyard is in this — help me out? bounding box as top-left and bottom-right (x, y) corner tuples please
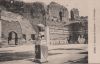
(34, 24), (48, 63)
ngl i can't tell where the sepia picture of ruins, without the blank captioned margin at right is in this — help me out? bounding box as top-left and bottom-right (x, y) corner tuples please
(0, 0), (87, 64)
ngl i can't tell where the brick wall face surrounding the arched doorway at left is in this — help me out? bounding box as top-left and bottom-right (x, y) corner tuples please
(2, 20), (22, 39)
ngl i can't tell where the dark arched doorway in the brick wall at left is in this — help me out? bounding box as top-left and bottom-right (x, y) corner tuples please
(8, 31), (18, 45)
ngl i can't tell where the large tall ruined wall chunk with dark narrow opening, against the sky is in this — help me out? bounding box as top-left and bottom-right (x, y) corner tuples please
(47, 2), (69, 22)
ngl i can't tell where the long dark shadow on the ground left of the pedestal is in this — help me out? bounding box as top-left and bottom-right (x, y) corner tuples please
(0, 52), (34, 62)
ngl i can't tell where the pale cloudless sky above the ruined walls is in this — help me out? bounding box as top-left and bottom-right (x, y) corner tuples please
(20, 0), (88, 16)
